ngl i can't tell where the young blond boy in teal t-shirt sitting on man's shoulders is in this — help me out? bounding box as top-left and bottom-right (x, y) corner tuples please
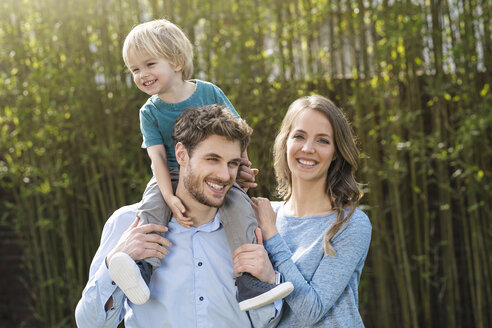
(108, 19), (293, 311)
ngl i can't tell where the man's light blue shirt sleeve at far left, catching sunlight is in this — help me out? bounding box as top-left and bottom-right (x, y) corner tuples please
(75, 206), (135, 328)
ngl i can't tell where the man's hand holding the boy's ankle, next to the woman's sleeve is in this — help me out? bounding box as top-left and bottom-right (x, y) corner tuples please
(232, 228), (275, 284)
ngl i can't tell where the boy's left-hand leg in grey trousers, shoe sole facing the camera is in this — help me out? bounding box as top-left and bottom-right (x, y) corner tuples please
(109, 169), (179, 304)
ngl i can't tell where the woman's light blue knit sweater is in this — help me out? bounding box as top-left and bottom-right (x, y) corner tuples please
(264, 202), (372, 328)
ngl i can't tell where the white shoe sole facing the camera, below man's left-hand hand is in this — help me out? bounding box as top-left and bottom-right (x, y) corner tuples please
(109, 253), (150, 304)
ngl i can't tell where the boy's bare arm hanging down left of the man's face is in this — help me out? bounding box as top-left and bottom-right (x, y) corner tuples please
(147, 145), (193, 227)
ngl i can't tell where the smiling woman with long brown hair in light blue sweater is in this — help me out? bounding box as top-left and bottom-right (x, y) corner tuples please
(234, 95), (371, 328)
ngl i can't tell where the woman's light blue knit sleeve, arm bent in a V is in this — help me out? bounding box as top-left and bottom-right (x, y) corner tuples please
(264, 216), (372, 326)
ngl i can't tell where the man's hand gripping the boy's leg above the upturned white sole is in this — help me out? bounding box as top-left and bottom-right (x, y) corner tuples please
(106, 217), (172, 266)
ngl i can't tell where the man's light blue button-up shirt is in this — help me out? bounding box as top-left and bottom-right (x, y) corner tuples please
(75, 204), (281, 328)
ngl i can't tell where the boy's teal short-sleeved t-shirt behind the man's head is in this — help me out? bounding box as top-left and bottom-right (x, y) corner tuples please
(140, 80), (239, 168)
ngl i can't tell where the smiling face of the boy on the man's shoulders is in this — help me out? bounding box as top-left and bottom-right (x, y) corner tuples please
(128, 51), (183, 98)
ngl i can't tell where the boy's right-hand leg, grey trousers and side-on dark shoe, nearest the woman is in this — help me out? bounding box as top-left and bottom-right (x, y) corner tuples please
(219, 184), (294, 311)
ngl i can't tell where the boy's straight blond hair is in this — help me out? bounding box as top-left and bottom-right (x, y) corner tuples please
(123, 19), (193, 80)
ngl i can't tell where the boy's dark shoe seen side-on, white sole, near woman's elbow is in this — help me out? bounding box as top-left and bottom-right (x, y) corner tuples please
(236, 273), (294, 311)
